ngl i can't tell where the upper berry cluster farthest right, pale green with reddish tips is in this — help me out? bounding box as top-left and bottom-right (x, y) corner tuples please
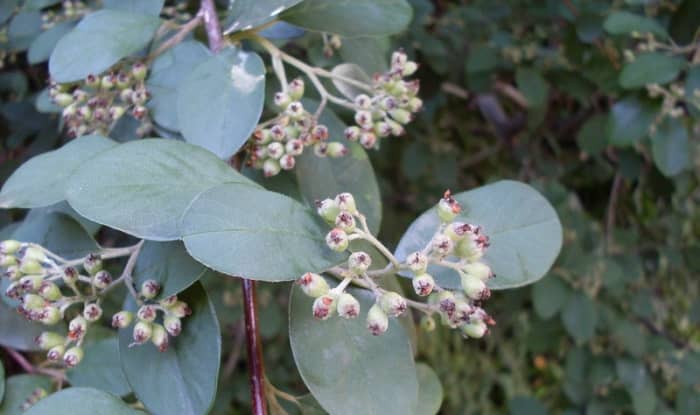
(345, 51), (423, 149)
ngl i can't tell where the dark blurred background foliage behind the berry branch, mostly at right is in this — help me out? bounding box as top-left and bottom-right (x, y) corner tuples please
(0, 0), (700, 415)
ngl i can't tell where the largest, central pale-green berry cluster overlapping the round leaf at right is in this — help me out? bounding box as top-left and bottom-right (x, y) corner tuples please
(298, 191), (495, 338)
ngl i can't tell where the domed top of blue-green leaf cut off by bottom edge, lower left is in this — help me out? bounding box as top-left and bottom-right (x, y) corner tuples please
(24, 388), (143, 415)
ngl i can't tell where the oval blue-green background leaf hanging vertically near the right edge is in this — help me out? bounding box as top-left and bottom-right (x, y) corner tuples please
(651, 118), (691, 177)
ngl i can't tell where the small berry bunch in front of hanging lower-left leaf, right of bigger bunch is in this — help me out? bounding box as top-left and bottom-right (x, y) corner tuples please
(112, 288), (192, 352)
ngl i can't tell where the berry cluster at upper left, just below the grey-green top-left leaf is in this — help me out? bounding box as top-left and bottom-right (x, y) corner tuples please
(49, 62), (153, 137)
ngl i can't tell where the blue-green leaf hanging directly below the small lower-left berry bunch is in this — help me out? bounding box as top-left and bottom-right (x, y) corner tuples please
(119, 283), (221, 415)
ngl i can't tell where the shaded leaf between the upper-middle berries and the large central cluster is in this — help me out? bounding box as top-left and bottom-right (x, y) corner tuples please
(294, 100), (382, 233)
